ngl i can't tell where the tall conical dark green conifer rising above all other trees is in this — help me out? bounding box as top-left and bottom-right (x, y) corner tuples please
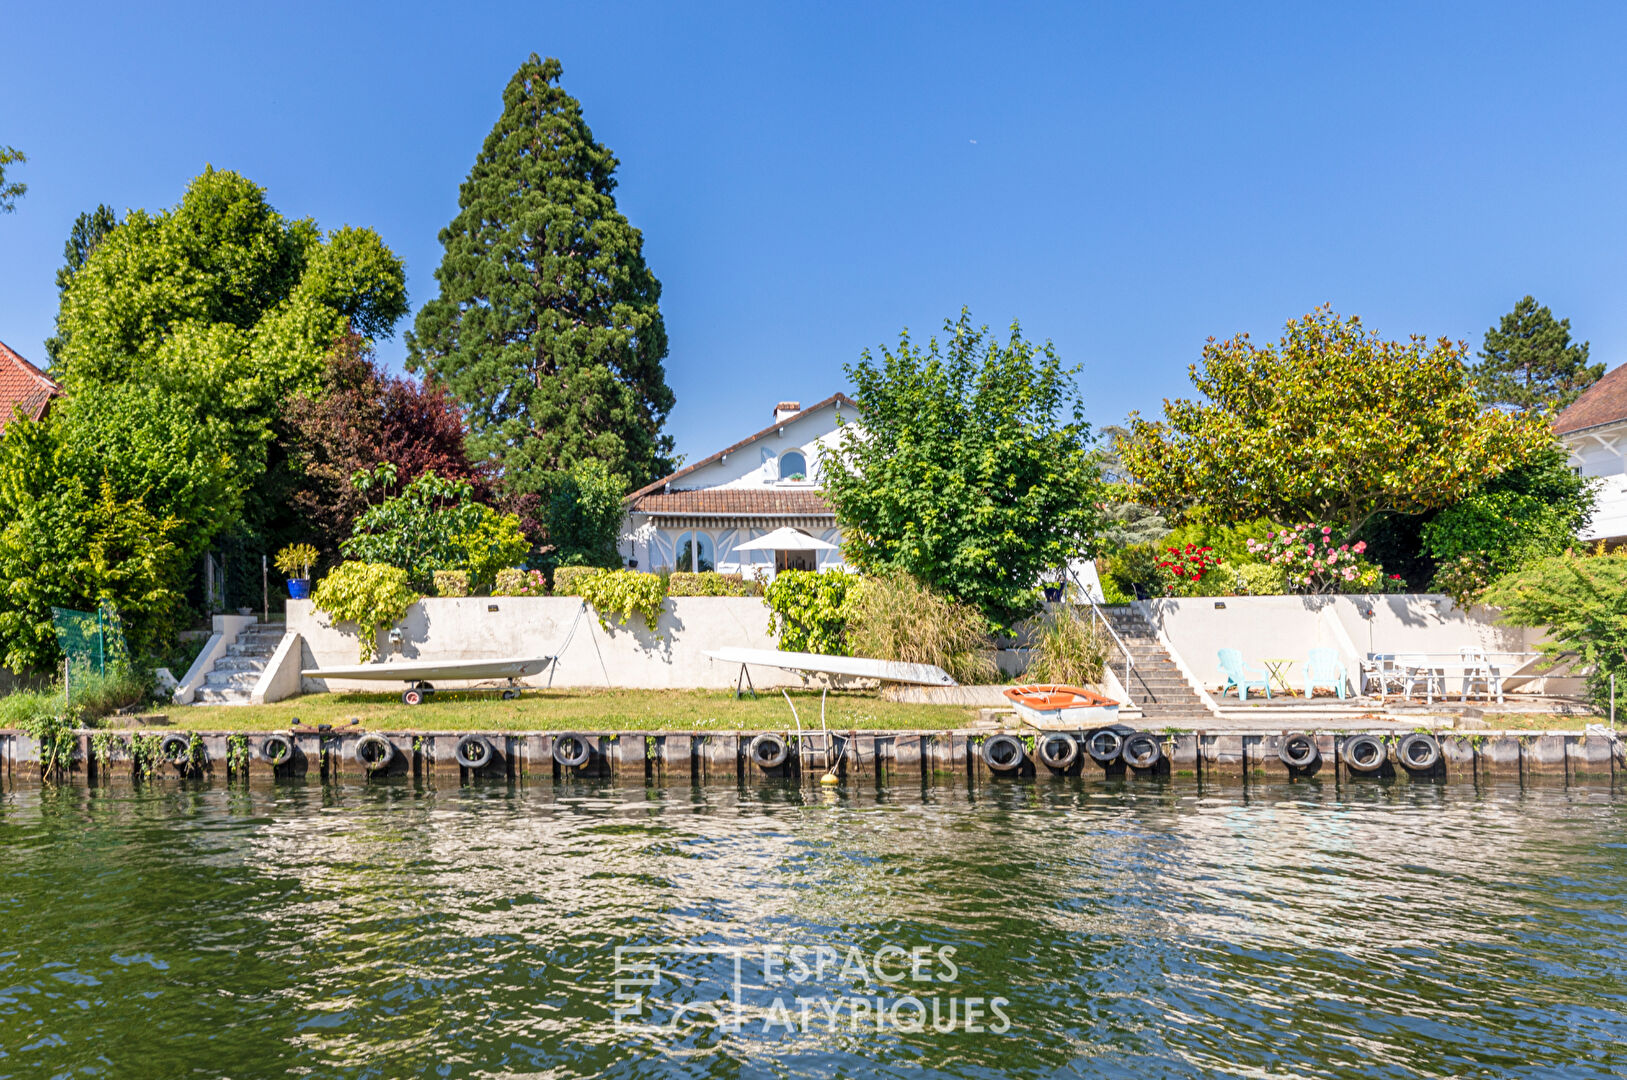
(407, 55), (674, 494)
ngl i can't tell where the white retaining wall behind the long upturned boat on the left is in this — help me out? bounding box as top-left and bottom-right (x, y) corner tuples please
(288, 597), (802, 693)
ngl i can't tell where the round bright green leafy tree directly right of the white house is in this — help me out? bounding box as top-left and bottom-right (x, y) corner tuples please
(823, 311), (1101, 625)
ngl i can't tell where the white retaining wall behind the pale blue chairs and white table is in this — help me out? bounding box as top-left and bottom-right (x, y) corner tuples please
(1134, 594), (1544, 690)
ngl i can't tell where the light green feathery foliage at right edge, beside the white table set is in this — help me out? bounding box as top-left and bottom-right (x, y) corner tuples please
(1482, 551), (1627, 709)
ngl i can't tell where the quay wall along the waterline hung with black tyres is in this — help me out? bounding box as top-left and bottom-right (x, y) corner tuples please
(0, 729), (1627, 787)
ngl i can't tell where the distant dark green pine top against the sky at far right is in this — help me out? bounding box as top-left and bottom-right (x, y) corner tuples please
(1474, 296), (1604, 412)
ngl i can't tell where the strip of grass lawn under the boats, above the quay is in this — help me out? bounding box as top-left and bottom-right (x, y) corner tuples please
(149, 690), (978, 732)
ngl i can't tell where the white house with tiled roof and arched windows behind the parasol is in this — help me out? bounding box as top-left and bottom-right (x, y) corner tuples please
(620, 394), (859, 577)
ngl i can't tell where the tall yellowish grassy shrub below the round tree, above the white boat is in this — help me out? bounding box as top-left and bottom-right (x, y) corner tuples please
(838, 571), (999, 685)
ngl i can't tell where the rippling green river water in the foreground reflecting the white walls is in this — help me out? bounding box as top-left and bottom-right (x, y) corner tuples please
(0, 782), (1627, 1078)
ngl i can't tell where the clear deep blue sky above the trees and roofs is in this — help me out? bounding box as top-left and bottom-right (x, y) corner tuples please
(0, 2), (1627, 460)
